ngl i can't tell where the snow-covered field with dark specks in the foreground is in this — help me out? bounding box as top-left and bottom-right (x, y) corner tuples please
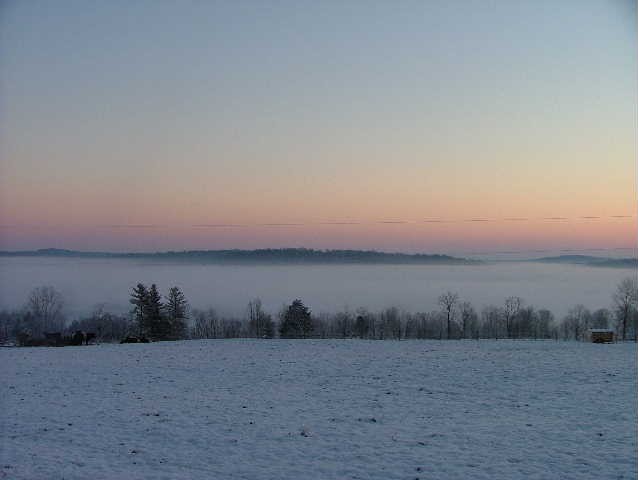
(0, 340), (636, 480)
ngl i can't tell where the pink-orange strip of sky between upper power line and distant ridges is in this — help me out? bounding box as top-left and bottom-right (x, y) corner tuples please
(0, 218), (637, 253)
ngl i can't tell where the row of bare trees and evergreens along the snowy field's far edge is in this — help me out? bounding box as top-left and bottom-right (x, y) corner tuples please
(0, 278), (638, 343)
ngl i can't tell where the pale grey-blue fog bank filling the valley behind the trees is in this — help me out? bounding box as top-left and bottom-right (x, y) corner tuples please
(0, 257), (634, 318)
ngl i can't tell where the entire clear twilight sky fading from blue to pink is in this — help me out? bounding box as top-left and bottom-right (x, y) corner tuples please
(0, 0), (638, 253)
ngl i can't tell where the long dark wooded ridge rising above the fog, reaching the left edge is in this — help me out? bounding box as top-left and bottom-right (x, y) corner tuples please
(0, 248), (483, 265)
